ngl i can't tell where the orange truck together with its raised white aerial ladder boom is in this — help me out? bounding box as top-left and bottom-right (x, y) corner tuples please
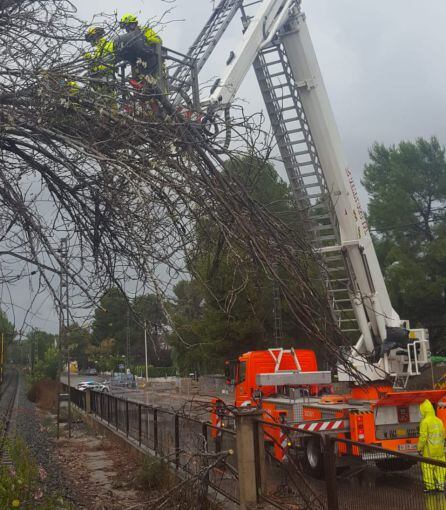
(172, 0), (446, 474)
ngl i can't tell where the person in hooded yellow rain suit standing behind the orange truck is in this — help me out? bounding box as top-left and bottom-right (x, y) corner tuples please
(418, 400), (446, 492)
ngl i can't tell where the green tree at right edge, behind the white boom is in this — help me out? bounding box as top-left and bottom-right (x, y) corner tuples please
(362, 138), (446, 353)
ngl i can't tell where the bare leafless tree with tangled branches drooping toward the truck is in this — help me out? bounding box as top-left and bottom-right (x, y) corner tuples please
(0, 0), (362, 380)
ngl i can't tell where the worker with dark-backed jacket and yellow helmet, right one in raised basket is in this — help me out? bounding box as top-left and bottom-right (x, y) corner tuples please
(118, 14), (162, 83)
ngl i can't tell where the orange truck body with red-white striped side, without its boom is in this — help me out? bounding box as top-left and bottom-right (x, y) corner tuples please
(212, 348), (446, 477)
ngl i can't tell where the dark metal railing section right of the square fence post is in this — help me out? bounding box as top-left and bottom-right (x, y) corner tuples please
(260, 422), (446, 510)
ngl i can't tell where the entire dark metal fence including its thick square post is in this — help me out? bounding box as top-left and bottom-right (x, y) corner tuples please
(63, 388), (446, 510)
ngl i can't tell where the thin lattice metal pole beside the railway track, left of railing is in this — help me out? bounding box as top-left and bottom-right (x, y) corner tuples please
(57, 237), (71, 438)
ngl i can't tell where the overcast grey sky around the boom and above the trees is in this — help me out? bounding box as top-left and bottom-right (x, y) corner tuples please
(8, 0), (446, 331)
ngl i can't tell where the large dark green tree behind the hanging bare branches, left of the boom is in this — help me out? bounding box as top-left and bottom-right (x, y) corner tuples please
(169, 156), (306, 373)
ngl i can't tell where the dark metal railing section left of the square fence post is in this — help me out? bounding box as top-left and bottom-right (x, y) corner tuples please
(66, 388), (239, 503)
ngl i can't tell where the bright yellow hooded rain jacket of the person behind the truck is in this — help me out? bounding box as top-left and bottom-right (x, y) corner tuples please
(418, 400), (445, 459)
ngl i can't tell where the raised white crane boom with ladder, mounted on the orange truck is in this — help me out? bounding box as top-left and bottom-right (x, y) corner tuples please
(184, 0), (429, 382)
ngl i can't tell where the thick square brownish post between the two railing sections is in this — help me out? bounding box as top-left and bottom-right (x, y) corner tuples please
(235, 409), (264, 510)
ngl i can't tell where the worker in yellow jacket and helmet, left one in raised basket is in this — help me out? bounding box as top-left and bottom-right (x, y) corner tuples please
(84, 26), (116, 84)
